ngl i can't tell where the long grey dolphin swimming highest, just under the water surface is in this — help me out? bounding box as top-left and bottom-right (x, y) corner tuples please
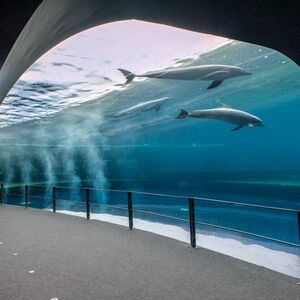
(118, 65), (251, 89)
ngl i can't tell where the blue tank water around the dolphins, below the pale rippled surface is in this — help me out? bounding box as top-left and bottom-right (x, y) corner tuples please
(0, 42), (300, 243)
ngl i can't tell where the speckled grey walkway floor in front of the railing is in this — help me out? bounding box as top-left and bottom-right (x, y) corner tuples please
(0, 206), (300, 300)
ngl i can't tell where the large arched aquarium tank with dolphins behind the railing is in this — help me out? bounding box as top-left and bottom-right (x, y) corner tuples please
(0, 20), (300, 276)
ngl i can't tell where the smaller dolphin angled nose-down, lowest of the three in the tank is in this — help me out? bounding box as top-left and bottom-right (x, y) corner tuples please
(176, 107), (264, 131)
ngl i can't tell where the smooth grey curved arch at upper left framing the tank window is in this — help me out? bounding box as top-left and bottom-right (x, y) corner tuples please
(0, 0), (125, 103)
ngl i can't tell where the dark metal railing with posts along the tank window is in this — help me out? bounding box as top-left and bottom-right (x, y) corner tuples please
(0, 183), (300, 248)
